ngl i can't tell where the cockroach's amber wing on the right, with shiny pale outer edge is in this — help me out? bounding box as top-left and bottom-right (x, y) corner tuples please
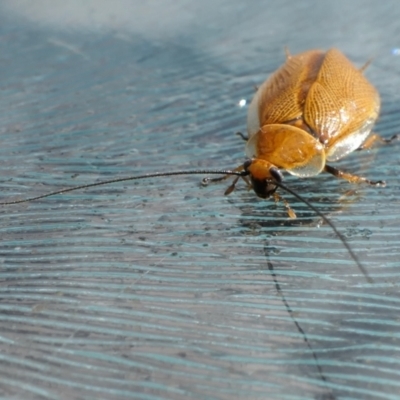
(304, 49), (380, 161)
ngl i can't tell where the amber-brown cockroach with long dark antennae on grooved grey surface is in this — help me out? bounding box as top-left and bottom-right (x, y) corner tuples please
(0, 49), (398, 282)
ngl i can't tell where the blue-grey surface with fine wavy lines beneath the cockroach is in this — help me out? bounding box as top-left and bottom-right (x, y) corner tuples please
(0, 0), (400, 400)
